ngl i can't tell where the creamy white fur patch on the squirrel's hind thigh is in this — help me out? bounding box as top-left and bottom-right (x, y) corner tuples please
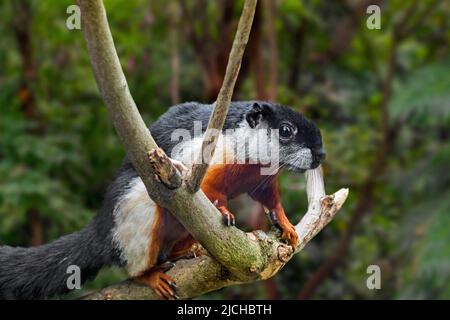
(113, 177), (156, 276)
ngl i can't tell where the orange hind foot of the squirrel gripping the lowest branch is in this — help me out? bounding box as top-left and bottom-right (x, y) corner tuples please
(135, 262), (180, 300)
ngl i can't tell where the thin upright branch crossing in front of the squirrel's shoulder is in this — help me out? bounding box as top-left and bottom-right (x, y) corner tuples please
(187, 0), (257, 192)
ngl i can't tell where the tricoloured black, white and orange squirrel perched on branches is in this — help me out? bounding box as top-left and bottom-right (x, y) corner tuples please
(0, 101), (325, 299)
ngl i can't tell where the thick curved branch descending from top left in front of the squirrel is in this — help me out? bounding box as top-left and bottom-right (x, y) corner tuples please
(78, 0), (264, 278)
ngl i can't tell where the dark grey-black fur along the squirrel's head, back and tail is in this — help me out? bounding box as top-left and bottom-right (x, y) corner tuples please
(0, 101), (322, 299)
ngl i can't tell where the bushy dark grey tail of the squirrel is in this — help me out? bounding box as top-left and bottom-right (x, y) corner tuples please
(0, 219), (115, 299)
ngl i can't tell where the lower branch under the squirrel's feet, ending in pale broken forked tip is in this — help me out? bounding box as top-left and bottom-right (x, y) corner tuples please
(84, 169), (348, 300)
